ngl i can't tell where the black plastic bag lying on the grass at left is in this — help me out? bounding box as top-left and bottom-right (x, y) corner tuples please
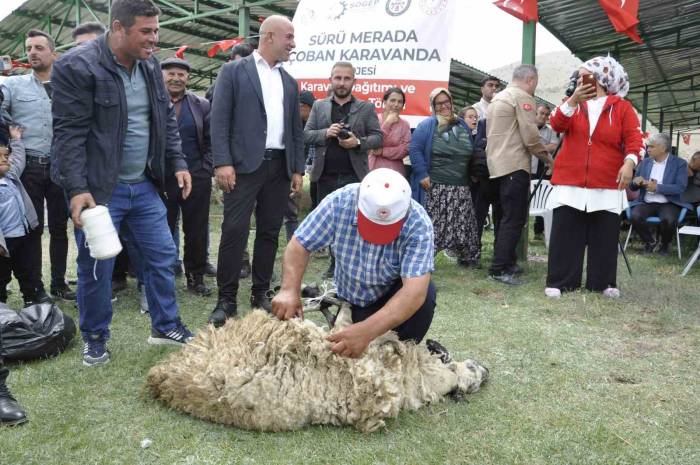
(0, 302), (75, 361)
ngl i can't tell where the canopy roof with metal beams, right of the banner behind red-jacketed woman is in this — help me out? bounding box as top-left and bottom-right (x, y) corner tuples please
(538, 0), (700, 132)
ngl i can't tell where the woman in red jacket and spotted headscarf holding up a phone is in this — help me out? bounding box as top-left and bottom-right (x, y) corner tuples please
(545, 56), (642, 298)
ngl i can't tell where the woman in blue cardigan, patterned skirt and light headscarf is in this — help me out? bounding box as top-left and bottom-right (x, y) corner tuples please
(408, 87), (480, 266)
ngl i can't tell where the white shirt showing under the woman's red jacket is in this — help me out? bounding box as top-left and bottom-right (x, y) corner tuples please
(548, 95), (637, 215)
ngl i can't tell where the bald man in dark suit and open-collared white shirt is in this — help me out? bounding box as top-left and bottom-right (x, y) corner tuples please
(209, 15), (304, 327)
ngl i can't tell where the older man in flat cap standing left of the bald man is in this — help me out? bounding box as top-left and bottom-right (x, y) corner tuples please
(160, 57), (213, 296)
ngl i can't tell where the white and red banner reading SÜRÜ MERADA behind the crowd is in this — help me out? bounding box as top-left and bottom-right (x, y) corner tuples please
(285, 0), (456, 127)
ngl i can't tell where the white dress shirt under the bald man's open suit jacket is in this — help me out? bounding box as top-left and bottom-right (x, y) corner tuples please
(253, 50), (284, 149)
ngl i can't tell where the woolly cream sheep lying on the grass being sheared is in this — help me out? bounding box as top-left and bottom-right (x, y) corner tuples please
(147, 310), (488, 432)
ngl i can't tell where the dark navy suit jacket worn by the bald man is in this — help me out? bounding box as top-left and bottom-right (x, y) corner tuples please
(211, 54), (305, 179)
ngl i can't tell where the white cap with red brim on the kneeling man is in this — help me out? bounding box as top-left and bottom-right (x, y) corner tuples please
(357, 168), (411, 245)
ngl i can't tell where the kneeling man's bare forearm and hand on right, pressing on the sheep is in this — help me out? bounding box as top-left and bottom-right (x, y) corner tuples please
(327, 273), (431, 358)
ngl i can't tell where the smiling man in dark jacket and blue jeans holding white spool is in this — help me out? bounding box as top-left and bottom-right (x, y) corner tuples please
(51, 0), (192, 366)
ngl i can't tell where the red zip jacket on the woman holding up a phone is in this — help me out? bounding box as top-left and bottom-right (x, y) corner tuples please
(549, 95), (643, 189)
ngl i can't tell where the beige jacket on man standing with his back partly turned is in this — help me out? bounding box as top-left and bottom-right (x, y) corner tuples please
(486, 84), (547, 178)
